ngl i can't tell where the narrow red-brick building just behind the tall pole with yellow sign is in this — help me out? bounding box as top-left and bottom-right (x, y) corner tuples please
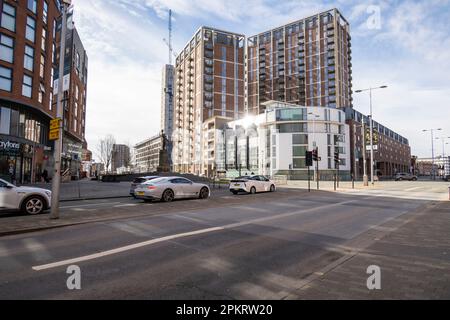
(53, 28), (88, 175)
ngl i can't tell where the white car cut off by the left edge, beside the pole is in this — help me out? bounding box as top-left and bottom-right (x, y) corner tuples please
(0, 179), (52, 214)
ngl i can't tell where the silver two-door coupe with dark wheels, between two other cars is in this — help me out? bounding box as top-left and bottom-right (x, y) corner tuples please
(134, 177), (211, 202)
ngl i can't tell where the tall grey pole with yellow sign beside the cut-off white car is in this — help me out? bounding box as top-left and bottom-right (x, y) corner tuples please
(50, 0), (72, 219)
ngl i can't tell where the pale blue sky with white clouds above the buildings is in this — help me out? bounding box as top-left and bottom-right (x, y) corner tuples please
(73, 0), (450, 158)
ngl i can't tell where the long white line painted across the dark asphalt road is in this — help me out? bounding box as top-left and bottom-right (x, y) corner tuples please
(32, 199), (360, 271)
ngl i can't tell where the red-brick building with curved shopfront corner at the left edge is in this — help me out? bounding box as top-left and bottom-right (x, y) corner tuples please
(0, 0), (60, 183)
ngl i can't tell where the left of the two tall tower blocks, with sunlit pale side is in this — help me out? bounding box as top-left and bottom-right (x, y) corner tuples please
(172, 27), (245, 174)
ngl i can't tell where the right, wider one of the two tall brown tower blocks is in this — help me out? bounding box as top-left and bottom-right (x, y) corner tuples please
(247, 9), (352, 114)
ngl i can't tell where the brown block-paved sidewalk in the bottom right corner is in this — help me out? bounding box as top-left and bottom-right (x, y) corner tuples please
(288, 202), (450, 299)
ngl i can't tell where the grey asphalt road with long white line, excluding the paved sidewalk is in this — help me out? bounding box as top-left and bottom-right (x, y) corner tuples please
(0, 184), (446, 299)
